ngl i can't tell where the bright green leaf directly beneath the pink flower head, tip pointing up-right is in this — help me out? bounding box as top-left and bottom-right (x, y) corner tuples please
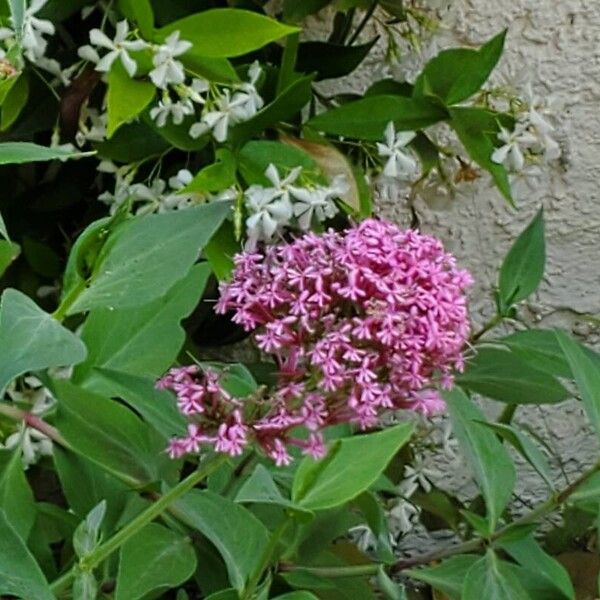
(292, 423), (413, 510)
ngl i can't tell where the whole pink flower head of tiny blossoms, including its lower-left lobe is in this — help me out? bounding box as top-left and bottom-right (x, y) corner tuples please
(159, 219), (472, 465)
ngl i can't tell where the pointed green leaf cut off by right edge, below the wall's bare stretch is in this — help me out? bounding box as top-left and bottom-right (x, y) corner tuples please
(556, 331), (600, 437)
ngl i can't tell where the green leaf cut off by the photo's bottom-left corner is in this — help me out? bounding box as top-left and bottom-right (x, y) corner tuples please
(0, 510), (54, 600)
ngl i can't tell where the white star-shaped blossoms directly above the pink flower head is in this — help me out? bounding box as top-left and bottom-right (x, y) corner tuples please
(244, 164), (348, 249)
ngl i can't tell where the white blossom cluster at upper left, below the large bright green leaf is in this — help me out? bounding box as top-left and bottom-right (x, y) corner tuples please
(78, 20), (264, 142)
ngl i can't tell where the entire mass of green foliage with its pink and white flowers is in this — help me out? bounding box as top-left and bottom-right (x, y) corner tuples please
(0, 0), (600, 600)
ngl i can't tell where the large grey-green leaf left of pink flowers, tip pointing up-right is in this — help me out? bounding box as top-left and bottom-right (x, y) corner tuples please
(70, 202), (229, 314)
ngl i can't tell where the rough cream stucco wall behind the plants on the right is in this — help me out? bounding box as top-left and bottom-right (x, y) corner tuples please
(315, 0), (600, 553)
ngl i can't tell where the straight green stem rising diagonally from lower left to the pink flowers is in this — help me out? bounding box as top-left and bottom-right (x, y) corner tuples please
(50, 455), (227, 594)
